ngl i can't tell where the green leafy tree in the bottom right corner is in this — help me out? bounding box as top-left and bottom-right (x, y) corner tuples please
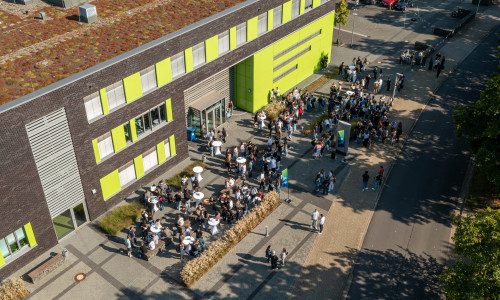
(439, 208), (500, 300)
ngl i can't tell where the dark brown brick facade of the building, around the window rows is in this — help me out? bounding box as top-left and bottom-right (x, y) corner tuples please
(0, 0), (335, 281)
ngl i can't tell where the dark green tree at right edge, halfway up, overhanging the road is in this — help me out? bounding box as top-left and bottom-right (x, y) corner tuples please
(453, 73), (500, 191)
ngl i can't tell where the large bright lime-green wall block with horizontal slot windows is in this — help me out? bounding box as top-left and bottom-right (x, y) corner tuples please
(235, 11), (333, 112)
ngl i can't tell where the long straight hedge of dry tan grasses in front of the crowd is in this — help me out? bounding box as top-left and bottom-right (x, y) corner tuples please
(181, 192), (280, 287)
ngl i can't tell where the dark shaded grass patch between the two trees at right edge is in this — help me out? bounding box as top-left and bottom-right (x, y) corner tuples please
(465, 169), (500, 211)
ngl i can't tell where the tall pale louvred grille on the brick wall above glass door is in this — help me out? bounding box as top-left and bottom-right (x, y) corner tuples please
(26, 108), (85, 218)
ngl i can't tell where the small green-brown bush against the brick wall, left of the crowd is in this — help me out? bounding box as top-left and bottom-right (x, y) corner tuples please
(99, 202), (142, 235)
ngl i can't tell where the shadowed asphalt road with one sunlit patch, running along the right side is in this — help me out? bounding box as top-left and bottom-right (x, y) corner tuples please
(348, 27), (500, 299)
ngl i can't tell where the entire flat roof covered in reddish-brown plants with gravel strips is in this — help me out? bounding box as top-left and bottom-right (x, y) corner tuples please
(0, 0), (248, 106)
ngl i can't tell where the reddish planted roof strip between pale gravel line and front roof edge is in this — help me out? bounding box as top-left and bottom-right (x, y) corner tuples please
(0, 0), (244, 105)
